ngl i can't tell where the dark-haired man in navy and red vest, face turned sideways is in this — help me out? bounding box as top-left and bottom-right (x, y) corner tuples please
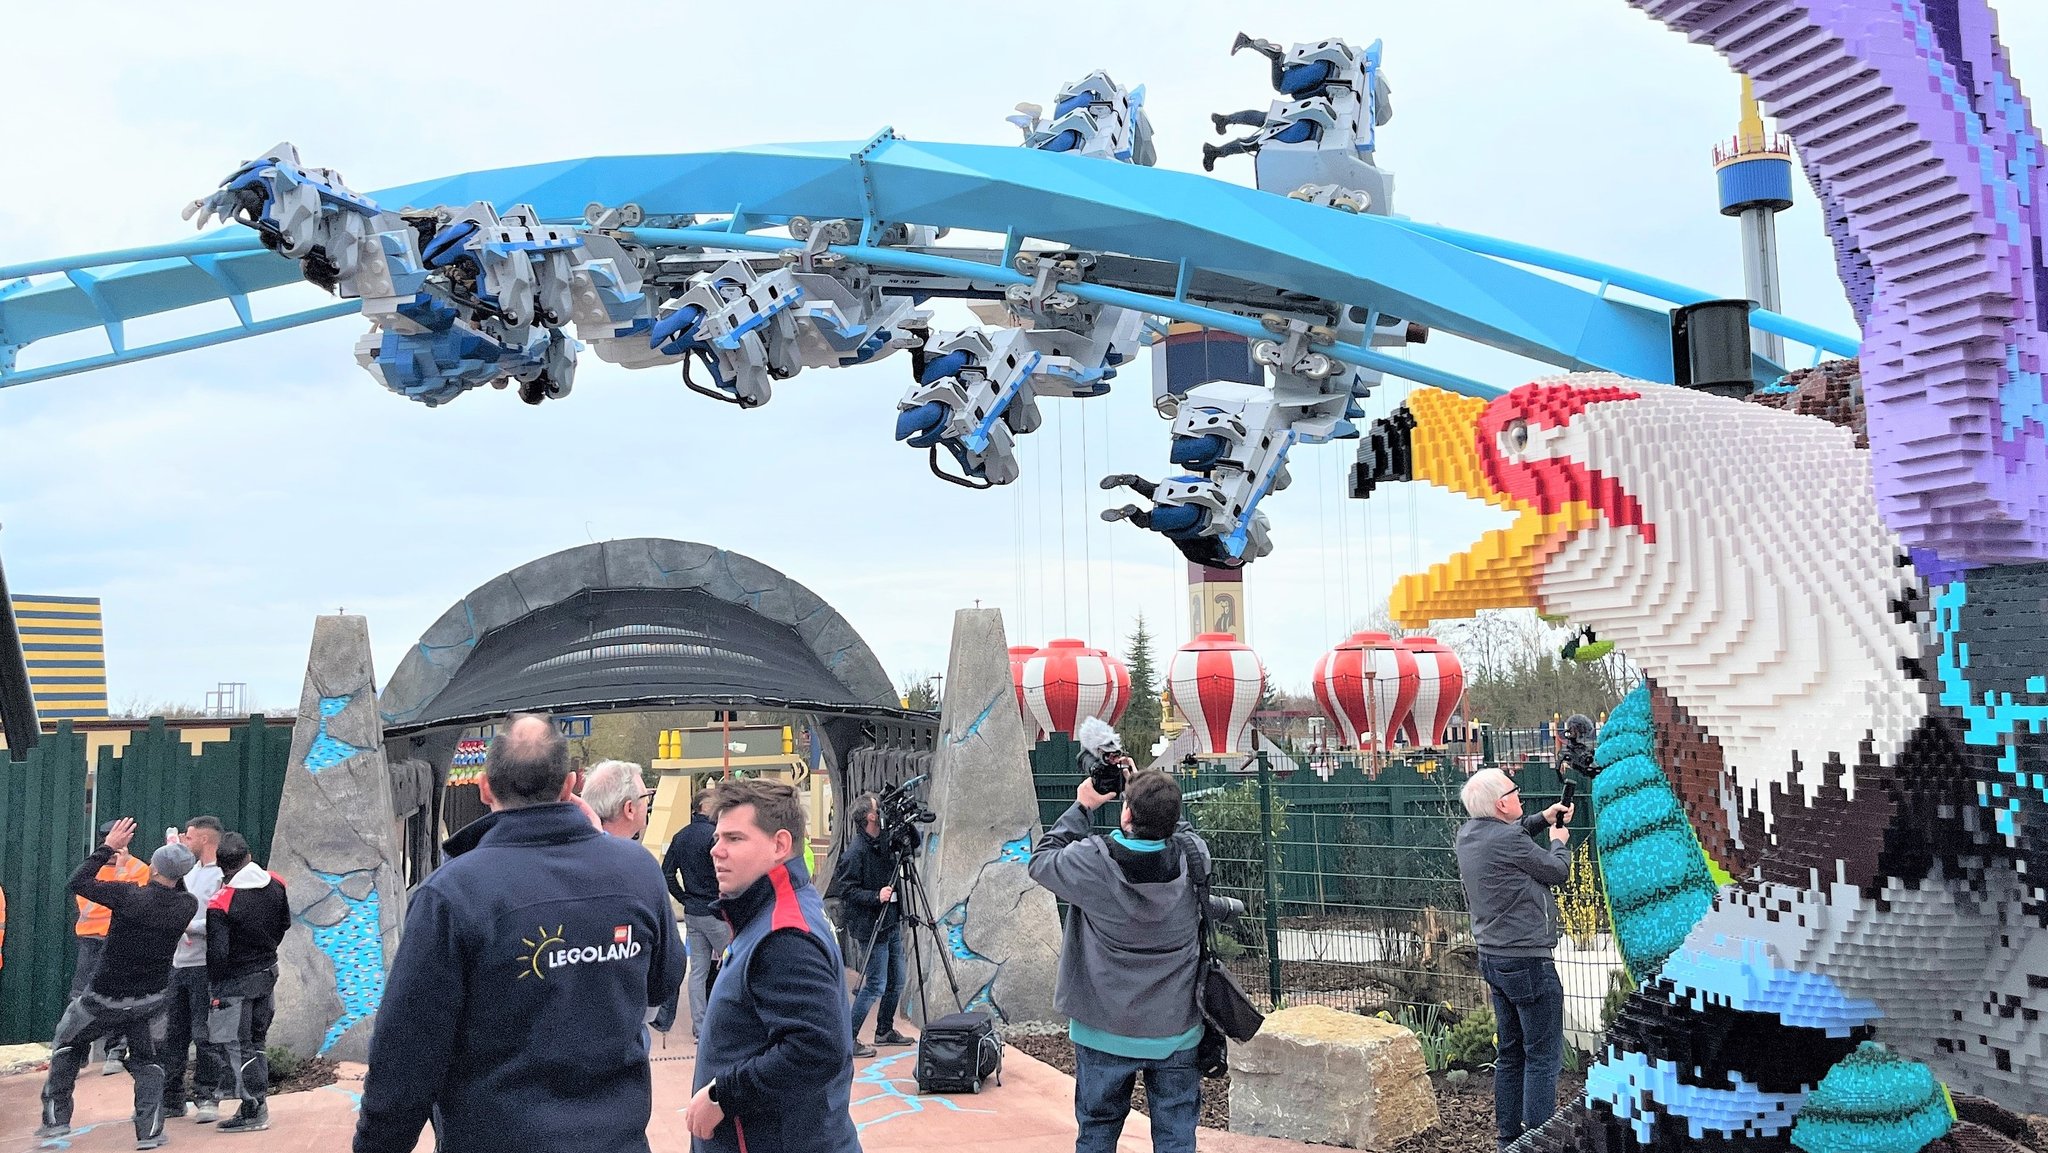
(682, 780), (860, 1153)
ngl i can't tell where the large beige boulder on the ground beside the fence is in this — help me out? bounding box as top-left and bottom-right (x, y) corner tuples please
(1231, 1006), (1436, 1149)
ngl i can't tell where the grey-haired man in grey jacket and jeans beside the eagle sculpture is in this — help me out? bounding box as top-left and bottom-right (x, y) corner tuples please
(1458, 768), (1571, 1149)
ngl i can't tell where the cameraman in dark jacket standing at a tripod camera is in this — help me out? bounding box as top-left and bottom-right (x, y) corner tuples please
(827, 793), (922, 1057)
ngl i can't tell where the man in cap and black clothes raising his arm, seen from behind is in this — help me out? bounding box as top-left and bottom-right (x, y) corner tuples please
(35, 817), (199, 1149)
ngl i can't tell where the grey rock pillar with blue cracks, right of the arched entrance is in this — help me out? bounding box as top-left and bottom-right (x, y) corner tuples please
(905, 608), (1063, 1024)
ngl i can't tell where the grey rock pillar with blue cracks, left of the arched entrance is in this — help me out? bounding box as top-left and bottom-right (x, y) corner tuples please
(270, 616), (406, 1061)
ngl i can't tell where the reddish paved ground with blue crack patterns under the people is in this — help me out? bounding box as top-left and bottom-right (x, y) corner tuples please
(0, 1036), (1311, 1153)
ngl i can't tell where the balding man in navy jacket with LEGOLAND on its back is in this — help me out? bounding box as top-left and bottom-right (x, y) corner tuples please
(354, 715), (682, 1153)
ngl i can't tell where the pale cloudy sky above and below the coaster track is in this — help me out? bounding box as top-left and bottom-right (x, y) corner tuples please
(0, 0), (2048, 709)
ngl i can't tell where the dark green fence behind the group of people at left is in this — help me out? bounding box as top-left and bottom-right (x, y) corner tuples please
(0, 715), (291, 1044)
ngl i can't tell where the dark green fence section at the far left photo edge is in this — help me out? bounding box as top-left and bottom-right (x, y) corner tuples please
(0, 721), (92, 1044)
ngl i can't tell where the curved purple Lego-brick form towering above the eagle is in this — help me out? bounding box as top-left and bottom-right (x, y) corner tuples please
(1628, 0), (2048, 565)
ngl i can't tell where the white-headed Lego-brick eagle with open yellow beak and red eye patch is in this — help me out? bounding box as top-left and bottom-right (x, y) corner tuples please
(1362, 375), (2048, 1153)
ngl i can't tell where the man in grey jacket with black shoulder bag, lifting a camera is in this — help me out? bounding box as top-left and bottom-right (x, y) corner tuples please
(1030, 754), (1208, 1153)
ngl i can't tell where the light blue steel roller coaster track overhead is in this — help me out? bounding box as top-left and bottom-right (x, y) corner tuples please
(0, 133), (1858, 395)
